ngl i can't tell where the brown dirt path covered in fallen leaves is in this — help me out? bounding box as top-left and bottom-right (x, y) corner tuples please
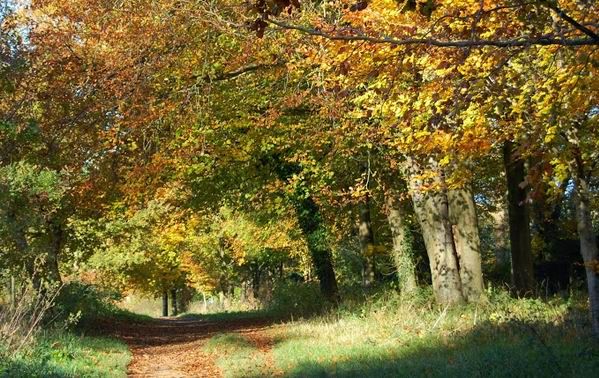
(109, 319), (271, 378)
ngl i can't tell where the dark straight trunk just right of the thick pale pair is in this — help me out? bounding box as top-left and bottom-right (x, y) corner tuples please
(503, 141), (534, 296)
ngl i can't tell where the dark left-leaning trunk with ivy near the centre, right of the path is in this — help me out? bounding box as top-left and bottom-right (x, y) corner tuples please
(295, 196), (339, 303)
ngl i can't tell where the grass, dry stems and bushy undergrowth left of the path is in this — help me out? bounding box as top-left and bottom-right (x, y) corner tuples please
(0, 282), (134, 378)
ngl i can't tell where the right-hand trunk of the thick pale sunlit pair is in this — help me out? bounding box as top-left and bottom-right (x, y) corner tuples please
(447, 188), (484, 302)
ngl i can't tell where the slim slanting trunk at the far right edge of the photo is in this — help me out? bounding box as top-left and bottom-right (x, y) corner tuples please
(575, 177), (599, 336)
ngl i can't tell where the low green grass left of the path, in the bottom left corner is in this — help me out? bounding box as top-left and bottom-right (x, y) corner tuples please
(0, 331), (131, 378)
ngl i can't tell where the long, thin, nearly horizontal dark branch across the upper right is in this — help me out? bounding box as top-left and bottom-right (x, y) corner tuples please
(266, 19), (599, 48)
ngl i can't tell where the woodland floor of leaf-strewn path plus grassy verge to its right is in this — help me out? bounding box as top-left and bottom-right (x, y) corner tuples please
(95, 291), (599, 378)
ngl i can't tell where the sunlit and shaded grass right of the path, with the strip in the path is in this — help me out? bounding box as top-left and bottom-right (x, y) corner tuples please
(202, 291), (599, 377)
